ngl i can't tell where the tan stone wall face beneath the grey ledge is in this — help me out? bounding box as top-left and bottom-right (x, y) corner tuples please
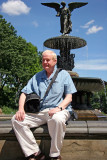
(0, 139), (107, 160)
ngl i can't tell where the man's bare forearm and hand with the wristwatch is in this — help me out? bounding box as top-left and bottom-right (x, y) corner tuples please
(48, 94), (72, 116)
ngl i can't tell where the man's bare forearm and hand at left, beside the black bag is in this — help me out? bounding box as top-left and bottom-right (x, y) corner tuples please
(15, 93), (26, 121)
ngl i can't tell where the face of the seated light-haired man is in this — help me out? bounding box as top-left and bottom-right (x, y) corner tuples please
(42, 53), (57, 72)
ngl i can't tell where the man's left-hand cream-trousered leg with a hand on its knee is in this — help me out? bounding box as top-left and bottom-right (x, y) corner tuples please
(12, 113), (46, 158)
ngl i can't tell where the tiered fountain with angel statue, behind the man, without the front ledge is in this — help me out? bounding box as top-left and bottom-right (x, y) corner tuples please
(41, 2), (106, 120)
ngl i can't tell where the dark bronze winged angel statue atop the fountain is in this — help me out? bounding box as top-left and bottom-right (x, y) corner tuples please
(41, 2), (88, 35)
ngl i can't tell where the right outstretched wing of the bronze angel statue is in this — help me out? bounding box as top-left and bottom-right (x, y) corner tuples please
(68, 2), (88, 12)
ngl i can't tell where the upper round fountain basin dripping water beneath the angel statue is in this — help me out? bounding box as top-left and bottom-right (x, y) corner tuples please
(44, 35), (87, 49)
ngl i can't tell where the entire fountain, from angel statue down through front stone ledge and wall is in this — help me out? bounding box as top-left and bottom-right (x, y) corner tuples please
(0, 2), (107, 160)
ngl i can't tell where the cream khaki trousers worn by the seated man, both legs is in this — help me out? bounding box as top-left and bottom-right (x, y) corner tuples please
(12, 109), (70, 157)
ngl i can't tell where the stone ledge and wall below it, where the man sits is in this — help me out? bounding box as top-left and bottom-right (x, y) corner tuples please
(0, 117), (107, 160)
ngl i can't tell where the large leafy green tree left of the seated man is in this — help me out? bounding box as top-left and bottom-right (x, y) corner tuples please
(0, 15), (42, 108)
